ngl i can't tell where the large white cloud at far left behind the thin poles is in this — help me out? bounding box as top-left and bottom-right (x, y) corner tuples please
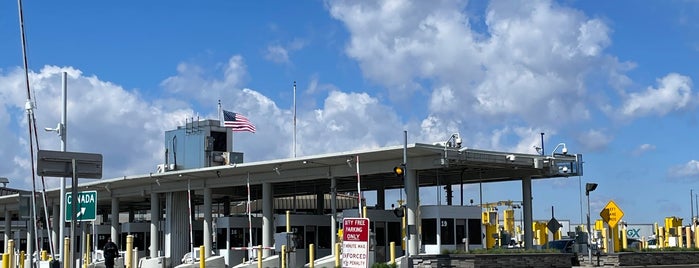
(0, 66), (192, 189)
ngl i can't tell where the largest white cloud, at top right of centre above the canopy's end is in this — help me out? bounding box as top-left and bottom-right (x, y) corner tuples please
(328, 0), (621, 142)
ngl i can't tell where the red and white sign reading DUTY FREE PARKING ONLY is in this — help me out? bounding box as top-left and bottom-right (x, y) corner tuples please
(341, 218), (369, 268)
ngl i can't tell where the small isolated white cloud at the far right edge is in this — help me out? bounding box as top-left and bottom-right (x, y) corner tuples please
(619, 73), (696, 118)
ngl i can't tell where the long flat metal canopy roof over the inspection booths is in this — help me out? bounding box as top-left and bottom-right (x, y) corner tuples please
(0, 143), (582, 214)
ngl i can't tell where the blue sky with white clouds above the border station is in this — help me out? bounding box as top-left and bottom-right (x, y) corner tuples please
(0, 0), (699, 223)
